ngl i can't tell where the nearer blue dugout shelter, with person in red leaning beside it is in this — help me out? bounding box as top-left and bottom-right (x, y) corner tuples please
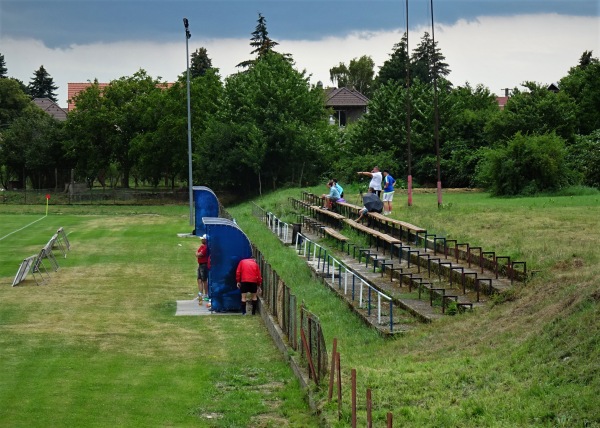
(202, 217), (252, 312)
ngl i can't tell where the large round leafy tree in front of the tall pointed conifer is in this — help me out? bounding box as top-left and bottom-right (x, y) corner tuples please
(201, 52), (328, 193)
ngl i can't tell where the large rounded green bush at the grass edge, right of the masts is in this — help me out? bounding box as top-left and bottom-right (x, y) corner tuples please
(477, 133), (571, 196)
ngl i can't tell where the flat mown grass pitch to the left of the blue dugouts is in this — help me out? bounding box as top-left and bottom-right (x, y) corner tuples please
(0, 206), (318, 427)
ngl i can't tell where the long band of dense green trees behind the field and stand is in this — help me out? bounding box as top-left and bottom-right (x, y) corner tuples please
(0, 29), (600, 195)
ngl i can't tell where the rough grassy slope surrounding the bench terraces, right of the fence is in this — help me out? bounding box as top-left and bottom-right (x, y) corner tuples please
(231, 189), (600, 427)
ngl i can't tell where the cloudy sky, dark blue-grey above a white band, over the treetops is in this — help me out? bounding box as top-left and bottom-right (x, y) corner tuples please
(0, 0), (600, 107)
